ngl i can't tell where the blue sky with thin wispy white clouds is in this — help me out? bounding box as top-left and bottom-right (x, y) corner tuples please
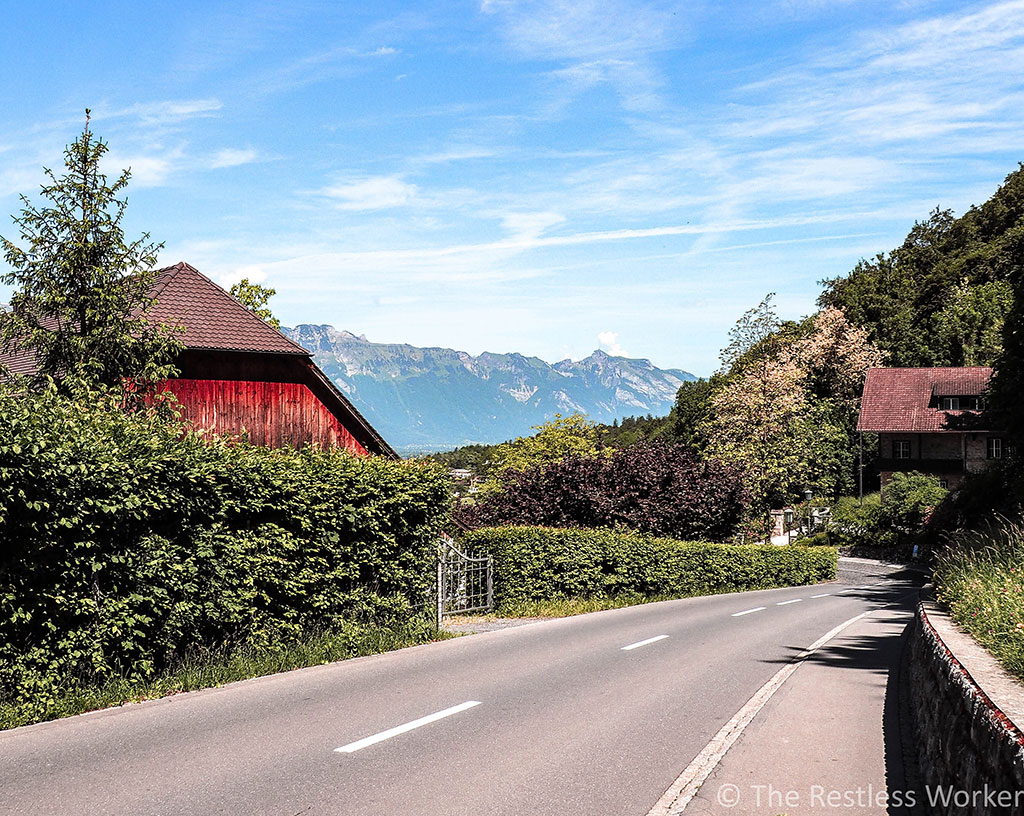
(0, 0), (1024, 375)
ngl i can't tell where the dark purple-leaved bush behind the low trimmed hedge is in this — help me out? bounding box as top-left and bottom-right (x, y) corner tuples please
(460, 441), (746, 541)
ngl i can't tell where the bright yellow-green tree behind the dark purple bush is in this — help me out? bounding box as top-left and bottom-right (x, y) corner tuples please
(481, 414), (600, 492)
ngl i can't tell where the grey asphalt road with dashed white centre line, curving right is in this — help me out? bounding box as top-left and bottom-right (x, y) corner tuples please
(0, 574), (925, 816)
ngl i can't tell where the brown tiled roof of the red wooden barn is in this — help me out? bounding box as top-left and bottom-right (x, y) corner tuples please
(145, 261), (309, 357)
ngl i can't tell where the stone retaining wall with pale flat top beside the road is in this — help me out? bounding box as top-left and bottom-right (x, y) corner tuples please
(910, 600), (1024, 816)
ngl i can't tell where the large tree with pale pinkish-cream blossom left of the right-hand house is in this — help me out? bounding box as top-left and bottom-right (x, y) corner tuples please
(697, 298), (881, 522)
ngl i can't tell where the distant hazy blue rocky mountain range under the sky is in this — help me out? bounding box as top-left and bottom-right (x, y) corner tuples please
(282, 324), (696, 455)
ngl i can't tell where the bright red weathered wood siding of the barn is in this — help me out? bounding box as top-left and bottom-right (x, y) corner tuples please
(166, 379), (367, 456)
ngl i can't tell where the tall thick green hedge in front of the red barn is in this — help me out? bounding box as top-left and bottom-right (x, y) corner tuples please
(0, 384), (450, 707)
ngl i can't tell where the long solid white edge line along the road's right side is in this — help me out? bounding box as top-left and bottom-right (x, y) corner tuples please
(647, 610), (873, 816)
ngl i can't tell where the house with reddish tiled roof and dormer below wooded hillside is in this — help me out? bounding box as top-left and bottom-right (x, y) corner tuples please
(857, 367), (1007, 487)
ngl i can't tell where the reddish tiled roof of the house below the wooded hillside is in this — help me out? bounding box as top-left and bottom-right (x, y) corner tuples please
(857, 367), (992, 433)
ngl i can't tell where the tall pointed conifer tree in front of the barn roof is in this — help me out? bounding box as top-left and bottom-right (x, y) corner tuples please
(0, 111), (181, 393)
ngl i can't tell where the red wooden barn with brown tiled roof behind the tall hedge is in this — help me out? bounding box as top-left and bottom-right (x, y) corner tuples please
(0, 262), (397, 458)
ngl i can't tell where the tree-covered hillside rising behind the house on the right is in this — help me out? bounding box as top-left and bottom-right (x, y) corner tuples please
(460, 162), (1024, 536)
